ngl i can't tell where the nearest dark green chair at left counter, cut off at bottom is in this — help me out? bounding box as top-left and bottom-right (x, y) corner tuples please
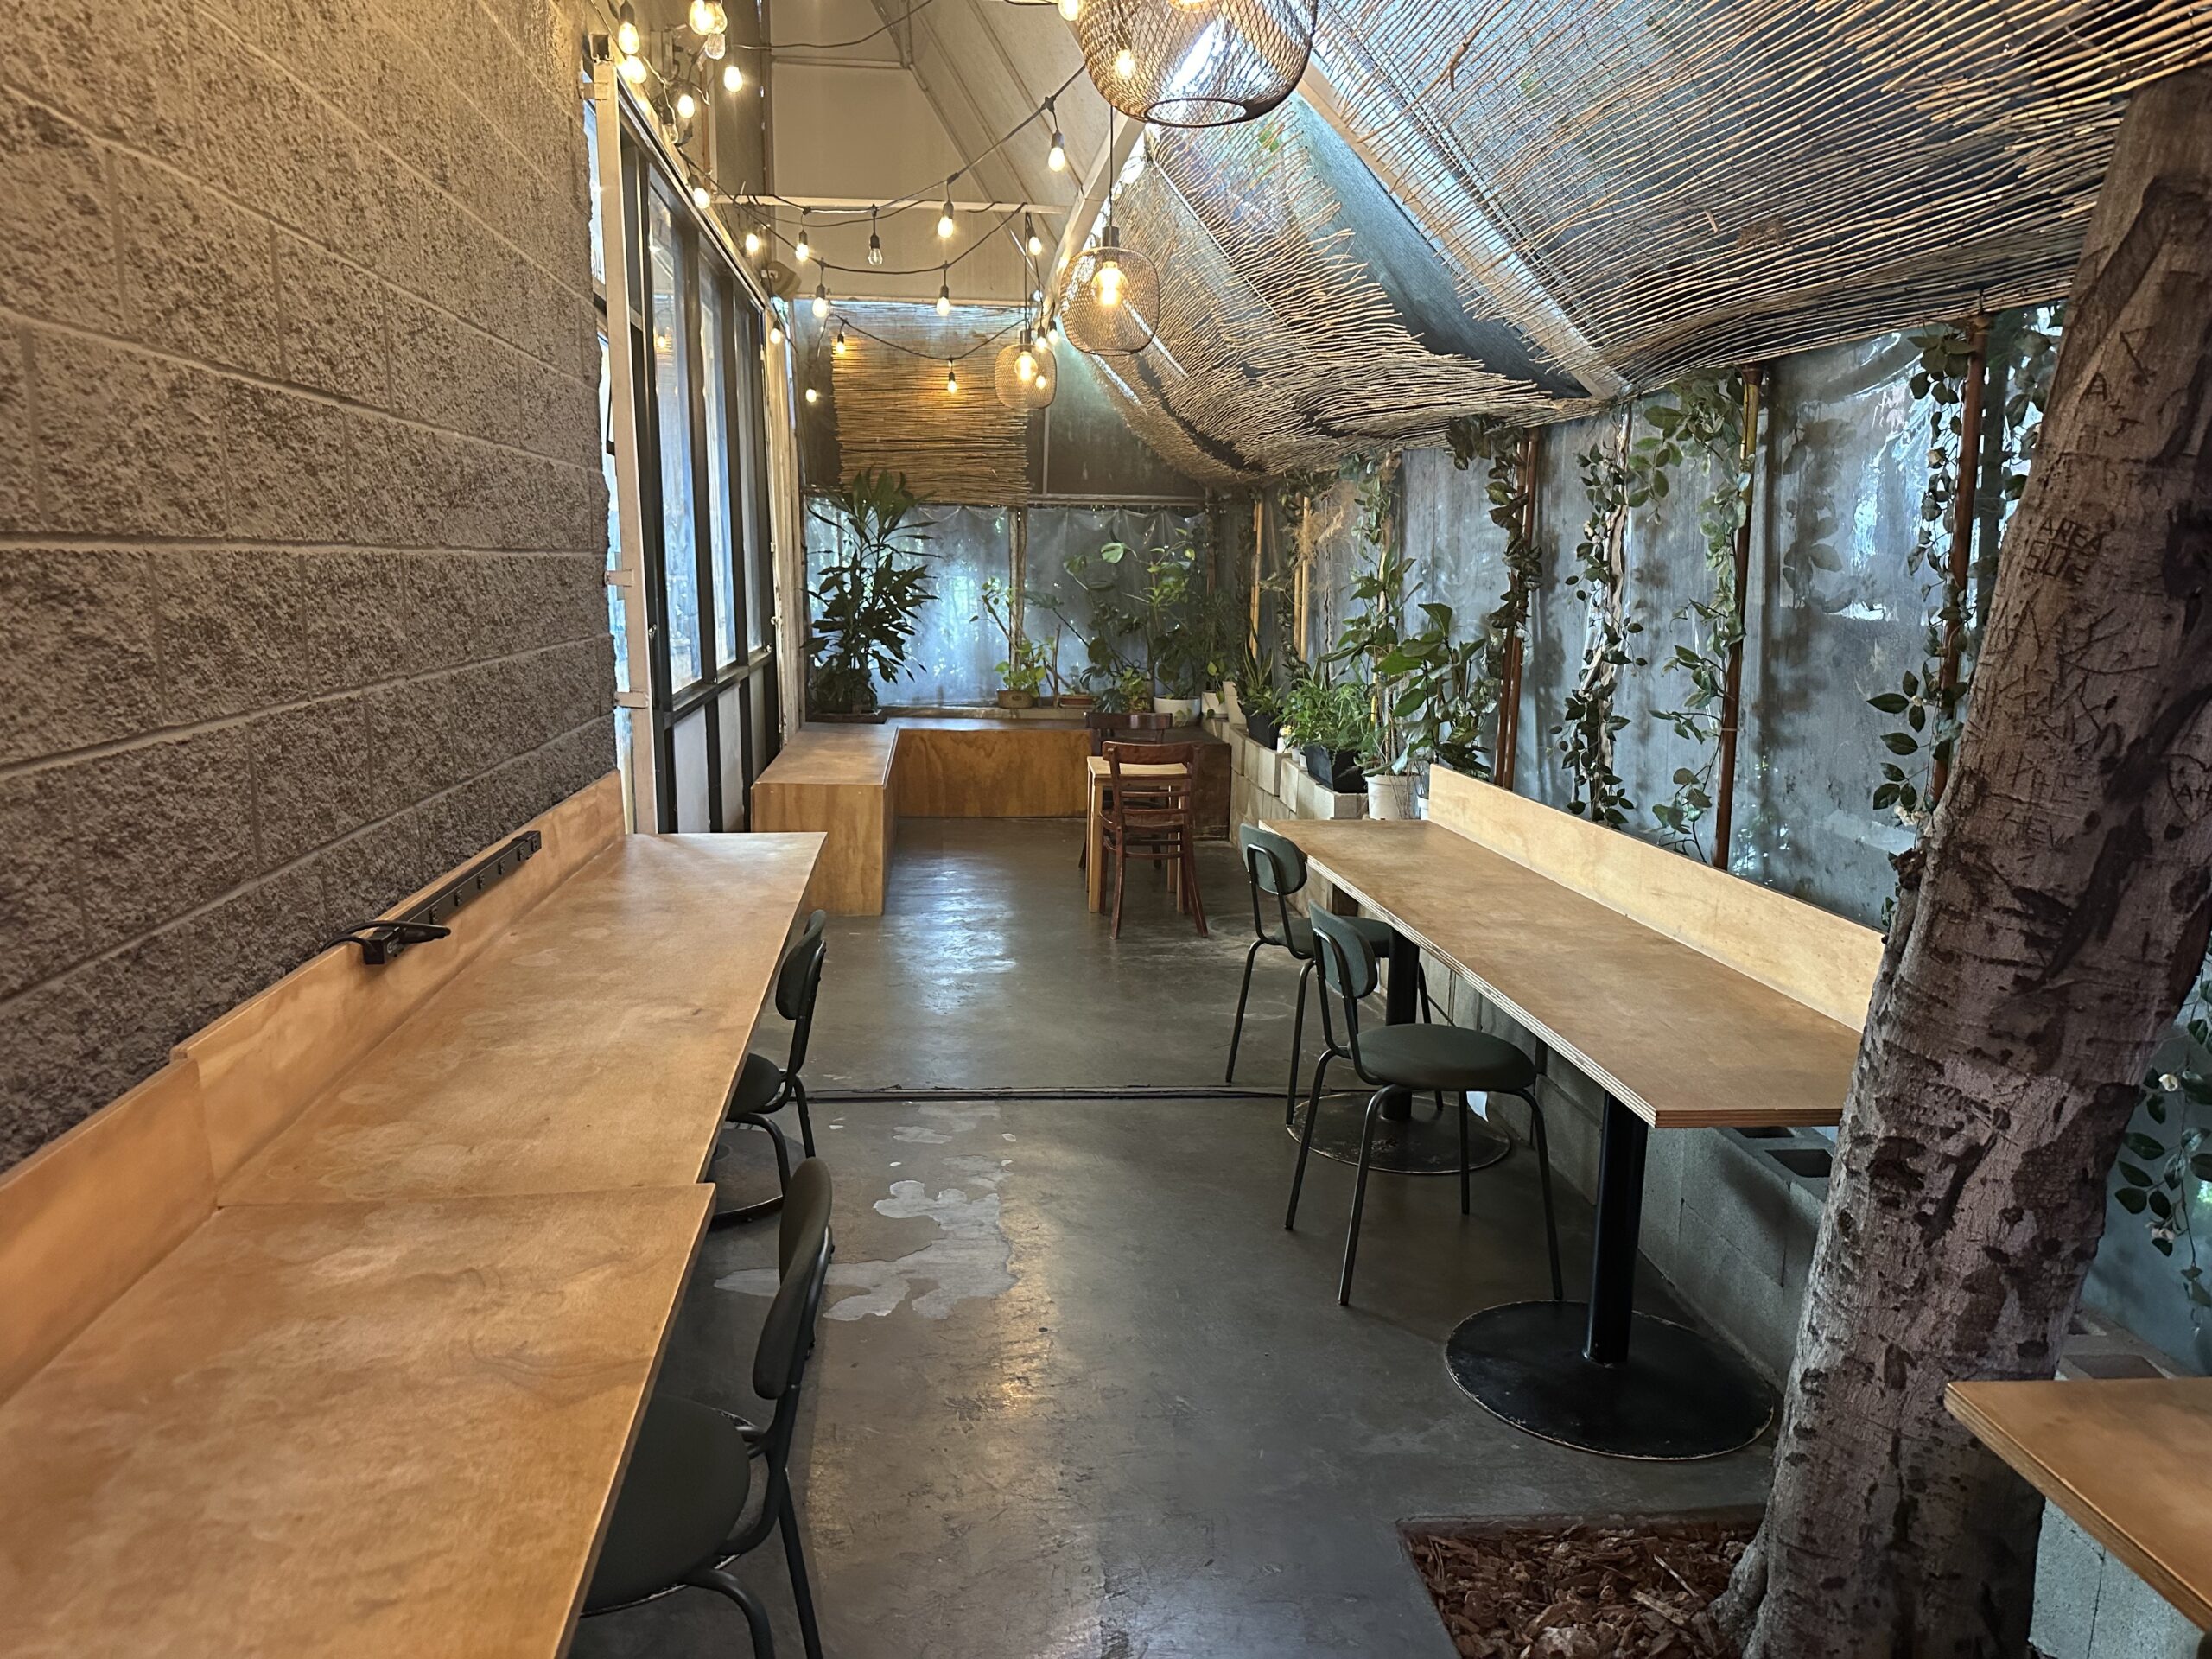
(584, 1159), (830, 1659)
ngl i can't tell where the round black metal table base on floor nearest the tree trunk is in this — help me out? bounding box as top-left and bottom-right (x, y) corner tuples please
(1445, 1303), (1774, 1460)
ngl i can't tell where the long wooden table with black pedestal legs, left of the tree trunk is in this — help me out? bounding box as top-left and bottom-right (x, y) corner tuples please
(1269, 821), (1858, 1458)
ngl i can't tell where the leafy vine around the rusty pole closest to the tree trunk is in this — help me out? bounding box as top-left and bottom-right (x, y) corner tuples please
(1867, 305), (2066, 836)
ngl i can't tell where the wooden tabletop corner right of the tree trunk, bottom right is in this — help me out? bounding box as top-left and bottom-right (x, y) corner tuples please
(1944, 1376), (2212, 1630)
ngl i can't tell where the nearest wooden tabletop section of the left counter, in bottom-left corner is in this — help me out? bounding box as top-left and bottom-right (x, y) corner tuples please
(0, 1185), (712, 1659)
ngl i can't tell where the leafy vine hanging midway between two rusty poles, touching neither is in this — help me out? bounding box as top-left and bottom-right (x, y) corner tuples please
(1551, 403), (1666, 830)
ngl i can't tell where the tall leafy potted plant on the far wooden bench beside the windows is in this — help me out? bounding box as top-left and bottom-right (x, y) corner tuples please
(807, 471), (931, 721)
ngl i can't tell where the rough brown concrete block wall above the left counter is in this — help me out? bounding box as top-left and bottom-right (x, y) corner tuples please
(0, 0), (613, 1166)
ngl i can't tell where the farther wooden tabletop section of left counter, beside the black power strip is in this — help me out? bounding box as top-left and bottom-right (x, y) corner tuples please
(219, 834), (823, 1204)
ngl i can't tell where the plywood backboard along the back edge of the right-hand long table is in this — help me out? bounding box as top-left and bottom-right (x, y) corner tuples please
(1429, 766), (1883, 1031)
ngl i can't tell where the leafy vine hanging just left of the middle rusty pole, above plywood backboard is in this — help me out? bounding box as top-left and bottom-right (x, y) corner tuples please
(1635, 372), (1752, 858)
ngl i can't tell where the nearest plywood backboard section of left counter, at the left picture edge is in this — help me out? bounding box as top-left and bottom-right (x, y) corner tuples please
(0, 1059), (214, 1400)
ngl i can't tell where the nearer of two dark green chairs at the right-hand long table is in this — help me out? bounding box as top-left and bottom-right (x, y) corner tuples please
(1283, 909), (1564, 1307)
